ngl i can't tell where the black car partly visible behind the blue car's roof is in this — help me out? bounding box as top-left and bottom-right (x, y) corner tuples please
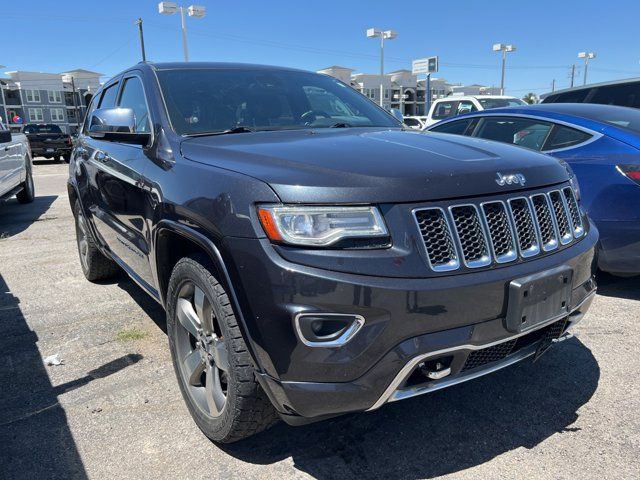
(541, 78), (640, 108)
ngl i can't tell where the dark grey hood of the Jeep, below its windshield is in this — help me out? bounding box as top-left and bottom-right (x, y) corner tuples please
(181, 128), (567, 203)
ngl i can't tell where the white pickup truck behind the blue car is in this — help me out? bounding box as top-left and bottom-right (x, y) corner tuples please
(424, 95), (526, 127)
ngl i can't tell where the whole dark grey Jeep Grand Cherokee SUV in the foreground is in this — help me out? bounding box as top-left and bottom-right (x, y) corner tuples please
(68, 63), (598, 442)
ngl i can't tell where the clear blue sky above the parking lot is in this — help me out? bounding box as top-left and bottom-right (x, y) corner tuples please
(0, 0), (640, 96)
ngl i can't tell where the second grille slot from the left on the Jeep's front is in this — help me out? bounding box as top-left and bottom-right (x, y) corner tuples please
(449, 205), (491, 268)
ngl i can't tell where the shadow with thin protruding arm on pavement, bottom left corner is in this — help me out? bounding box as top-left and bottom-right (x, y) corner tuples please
(0, 275), (142, 480)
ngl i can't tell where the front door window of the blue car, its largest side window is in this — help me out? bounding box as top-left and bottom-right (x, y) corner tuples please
(476, 117), (552, 150)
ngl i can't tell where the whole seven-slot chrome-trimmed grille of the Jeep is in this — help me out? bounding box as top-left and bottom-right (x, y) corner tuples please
(415, 187), (584, 272)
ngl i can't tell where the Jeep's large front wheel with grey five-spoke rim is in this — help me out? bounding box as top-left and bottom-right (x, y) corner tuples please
(167, 255), (278, 443)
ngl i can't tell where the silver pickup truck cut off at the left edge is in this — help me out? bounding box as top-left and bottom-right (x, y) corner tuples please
(0, 120), (35, 203)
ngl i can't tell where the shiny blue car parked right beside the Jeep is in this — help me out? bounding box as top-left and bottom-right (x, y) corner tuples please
(426, 103), (640, 276)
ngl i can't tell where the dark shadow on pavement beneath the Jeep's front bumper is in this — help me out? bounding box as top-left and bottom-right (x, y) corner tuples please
(224, 338), (600, 480)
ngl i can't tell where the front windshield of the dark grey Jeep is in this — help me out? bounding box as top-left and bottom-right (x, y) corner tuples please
(158, 68), (400, 135)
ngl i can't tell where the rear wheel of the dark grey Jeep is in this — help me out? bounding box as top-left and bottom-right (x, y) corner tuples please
(73, 200), (120, 282)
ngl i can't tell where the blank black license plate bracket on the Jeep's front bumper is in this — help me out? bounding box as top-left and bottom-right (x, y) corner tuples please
(505, 265), (573, 333)
